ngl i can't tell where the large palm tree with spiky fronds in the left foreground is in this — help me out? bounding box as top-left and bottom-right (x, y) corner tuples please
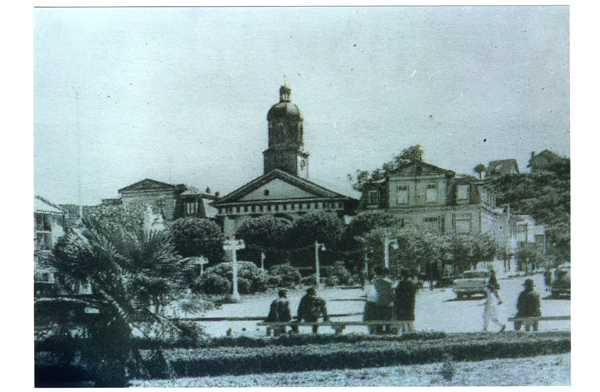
(45, 217), (204, 386)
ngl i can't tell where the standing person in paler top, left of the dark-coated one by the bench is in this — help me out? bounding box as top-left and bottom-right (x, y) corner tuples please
(363, 267), (394, 334)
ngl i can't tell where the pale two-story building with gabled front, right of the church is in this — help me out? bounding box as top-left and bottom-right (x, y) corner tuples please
(360, 161), (502, 238)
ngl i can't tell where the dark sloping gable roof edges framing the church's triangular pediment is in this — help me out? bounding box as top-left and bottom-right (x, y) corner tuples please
(213, 169), (354, 207)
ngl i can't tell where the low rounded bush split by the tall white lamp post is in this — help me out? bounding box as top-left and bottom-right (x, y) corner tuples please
(198, 261), (267, 294)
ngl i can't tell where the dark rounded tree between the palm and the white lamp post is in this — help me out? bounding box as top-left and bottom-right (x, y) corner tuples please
(169, 217), (225, 263)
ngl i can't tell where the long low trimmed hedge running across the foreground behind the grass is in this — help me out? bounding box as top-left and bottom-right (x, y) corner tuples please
(139, 333), (571, 378)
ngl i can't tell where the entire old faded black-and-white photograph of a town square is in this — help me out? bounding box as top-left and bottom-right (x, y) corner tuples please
(30, 5), (576, 388)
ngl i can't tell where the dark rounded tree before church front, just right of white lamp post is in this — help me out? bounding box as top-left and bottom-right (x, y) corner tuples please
(235, 216), (292, 267)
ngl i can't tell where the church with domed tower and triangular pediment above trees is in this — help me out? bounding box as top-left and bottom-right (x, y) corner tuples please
(213, 86), (358, 238)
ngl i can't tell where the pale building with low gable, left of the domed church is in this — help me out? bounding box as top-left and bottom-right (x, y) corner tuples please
(102, 179), (218, 221)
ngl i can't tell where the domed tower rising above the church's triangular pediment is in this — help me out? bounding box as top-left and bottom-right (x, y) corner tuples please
(263, 86), (308, 178)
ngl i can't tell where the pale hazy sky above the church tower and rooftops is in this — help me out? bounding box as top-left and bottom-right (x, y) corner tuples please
(33, 6), (570, 205)
